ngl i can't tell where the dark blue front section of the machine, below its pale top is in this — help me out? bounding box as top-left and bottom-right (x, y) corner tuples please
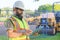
(38, 18), (56, 35)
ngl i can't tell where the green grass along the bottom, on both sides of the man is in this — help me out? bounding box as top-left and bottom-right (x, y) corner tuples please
(0, 33), (60, 40)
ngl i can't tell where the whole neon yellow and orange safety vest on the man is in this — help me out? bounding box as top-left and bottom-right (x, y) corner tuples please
(9, 16), (29, 40)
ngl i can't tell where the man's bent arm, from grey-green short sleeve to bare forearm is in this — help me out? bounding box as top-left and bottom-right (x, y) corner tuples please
(5, 20), (22, 37)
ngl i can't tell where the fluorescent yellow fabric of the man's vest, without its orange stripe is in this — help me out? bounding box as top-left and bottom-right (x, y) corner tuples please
(9, 16), (29, 40)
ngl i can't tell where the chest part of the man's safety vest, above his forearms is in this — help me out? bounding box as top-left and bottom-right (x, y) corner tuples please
(11, 17), (29, 30)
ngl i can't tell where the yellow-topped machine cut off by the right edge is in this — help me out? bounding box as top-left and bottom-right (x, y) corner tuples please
(53, 2), (60, 31)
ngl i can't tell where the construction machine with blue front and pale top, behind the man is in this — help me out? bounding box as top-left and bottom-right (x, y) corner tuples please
(36, 13), (56, 35)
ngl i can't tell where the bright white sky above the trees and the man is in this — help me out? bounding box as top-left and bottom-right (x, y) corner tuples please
(0, 0), (60, 11)
